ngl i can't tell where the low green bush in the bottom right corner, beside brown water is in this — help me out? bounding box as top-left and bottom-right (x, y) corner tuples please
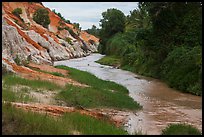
(162, 124), (201, 135)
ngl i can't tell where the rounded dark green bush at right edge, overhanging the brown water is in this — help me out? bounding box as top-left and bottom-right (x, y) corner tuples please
(162, 46), (202, 95)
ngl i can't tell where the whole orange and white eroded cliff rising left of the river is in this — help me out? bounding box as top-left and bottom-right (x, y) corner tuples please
(2, 2), (99, 71)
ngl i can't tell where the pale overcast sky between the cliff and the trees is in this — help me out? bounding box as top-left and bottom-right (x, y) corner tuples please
(43, 2), (138, 30)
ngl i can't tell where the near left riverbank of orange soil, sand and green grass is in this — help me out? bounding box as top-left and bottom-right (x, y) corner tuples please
(2, 64), (141, 135)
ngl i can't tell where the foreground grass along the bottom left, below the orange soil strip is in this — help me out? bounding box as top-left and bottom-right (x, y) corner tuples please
(2, 104), (127, 135)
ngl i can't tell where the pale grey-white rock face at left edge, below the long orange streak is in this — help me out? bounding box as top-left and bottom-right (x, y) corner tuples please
(2, 18), (52, 64)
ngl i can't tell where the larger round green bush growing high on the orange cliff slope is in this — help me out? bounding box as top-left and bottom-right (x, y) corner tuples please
(33, 8), (50, 28)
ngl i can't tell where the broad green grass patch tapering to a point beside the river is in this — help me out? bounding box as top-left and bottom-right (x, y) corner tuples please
(57, 85), (141, 110)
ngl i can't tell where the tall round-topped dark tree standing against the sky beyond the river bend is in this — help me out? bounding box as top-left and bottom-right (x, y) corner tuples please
(99, 8), (125, 54)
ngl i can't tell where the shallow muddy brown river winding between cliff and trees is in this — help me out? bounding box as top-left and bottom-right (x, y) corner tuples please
(54, 54), (202, 135)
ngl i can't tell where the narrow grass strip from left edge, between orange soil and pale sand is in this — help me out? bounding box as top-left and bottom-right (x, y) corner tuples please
(3, 75), (62, 90)
